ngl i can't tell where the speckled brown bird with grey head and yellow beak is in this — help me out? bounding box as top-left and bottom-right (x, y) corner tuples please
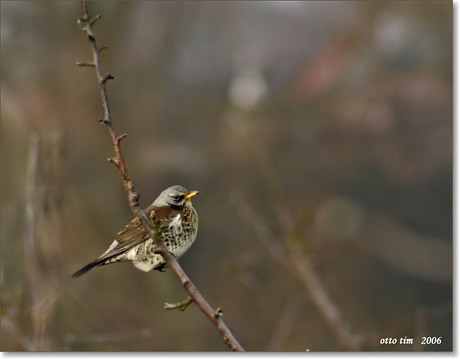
(72, 185), (200, 278)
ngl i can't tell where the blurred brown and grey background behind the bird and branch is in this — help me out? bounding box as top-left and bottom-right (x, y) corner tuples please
(0, 1), (453, 351)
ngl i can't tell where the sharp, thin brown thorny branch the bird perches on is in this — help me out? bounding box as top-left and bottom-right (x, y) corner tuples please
(77, 0), (244, 351)
